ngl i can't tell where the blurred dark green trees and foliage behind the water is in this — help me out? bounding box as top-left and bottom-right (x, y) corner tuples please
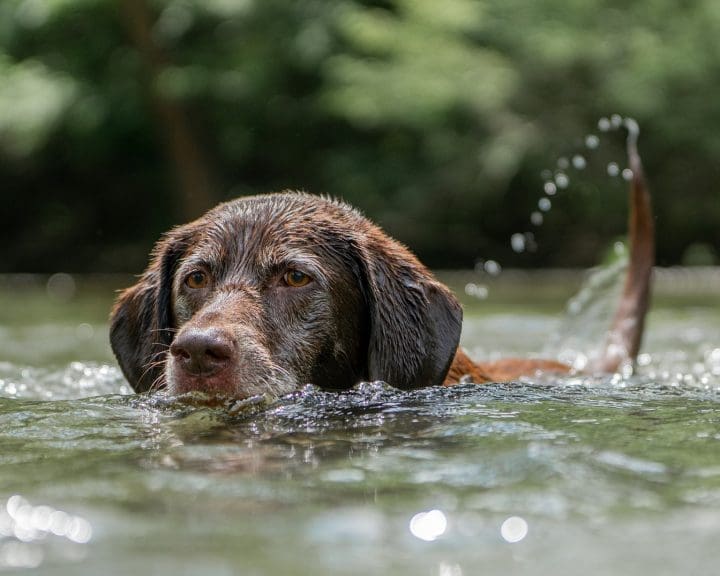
(0, 0), (720, 273)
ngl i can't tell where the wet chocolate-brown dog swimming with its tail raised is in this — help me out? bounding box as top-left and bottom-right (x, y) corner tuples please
(111, 133), (653, 398)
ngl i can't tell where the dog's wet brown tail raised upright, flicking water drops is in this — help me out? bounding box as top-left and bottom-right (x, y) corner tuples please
(593, 118), (655, 372)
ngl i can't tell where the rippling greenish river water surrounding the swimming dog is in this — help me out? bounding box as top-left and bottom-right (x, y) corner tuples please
(0, 271), (720, 576)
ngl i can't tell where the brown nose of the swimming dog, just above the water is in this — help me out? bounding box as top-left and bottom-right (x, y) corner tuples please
(170, 328), (235, 376)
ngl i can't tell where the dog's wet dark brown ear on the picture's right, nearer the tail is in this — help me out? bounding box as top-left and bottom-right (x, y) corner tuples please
(360, 230), (462, 389)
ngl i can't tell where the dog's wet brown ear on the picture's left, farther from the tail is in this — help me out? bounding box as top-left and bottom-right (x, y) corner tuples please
(110, 225), (194, 392)
